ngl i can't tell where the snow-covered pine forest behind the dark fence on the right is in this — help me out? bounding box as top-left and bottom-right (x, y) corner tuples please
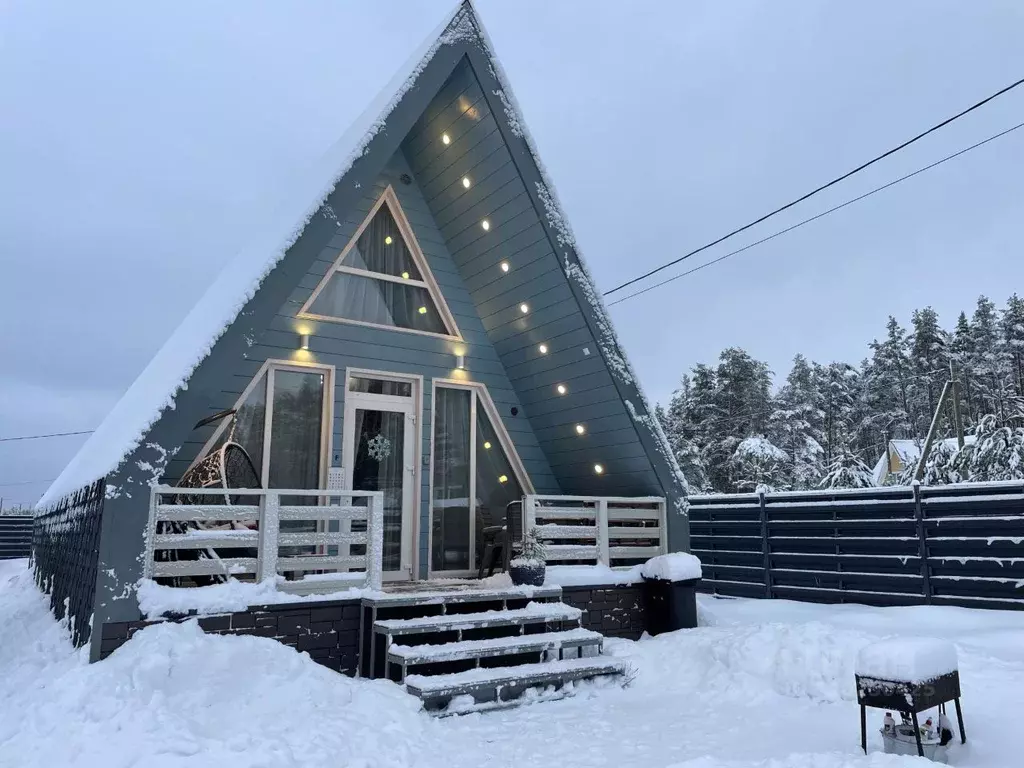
(657, 294), (1024, 494)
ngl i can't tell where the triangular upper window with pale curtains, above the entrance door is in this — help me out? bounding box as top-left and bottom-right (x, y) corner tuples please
(301, 186), (459, 338)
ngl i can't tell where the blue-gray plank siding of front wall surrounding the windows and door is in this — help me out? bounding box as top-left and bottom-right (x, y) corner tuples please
(159, 152), (560, 577)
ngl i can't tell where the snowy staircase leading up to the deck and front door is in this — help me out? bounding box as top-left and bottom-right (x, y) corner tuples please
(364, 587), (624, 715)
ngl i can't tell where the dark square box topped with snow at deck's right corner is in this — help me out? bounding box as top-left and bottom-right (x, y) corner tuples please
(640, 552), (700, 635)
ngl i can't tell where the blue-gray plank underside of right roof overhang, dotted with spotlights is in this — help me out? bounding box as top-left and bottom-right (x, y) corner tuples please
(402, 60), (663, 495)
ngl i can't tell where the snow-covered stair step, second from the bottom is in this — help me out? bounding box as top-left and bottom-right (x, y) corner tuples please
(388, 629), (604, 667)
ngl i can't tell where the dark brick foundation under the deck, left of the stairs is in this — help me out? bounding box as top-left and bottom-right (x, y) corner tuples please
(99, 600), (359, 675)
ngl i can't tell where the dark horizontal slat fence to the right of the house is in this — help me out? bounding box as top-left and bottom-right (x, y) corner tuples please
(690, 482), (1024, 609)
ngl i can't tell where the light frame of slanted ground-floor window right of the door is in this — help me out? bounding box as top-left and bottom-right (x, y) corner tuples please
(426, 379), (537, 579)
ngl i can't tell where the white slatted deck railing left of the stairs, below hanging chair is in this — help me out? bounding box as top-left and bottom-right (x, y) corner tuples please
(144, 485), (384, 594)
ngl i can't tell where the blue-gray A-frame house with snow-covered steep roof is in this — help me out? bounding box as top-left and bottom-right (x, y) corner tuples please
(37, 2), (688, 692)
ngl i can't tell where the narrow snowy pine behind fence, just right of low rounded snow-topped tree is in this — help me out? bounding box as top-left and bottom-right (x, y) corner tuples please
(769, 354), (824, 490)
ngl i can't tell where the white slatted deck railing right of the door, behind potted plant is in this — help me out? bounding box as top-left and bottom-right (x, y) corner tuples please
(523, 496), (669, 567)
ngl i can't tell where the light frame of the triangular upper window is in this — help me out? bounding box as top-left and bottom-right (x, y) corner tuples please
(297, 184), (463, 341)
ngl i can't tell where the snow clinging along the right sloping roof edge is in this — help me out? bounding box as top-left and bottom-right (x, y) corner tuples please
(474, 14), (690, 505)
